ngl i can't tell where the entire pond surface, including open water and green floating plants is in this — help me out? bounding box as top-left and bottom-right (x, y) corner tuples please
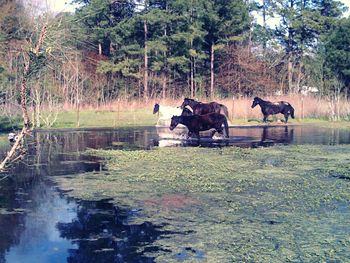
(0, 126), (350, 262)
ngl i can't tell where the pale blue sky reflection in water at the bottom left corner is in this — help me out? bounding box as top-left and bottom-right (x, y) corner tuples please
(0, 182), (76, 262)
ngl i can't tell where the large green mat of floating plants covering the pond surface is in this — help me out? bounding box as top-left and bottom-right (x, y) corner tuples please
(57, 145), (350, 262)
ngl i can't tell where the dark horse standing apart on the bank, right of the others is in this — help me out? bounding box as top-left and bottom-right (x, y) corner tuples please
(252, 97), (294, 123)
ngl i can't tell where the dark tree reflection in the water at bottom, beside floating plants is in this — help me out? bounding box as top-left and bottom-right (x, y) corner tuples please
(58, 201), (171, 263)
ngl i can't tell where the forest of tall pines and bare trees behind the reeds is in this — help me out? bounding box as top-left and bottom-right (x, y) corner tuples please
(0, 0), (350, 126)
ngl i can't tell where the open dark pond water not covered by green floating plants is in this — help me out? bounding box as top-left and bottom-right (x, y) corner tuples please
(0, 126), (350, 262)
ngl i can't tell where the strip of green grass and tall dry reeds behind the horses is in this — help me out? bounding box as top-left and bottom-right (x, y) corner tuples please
(0, 95), (350, 130)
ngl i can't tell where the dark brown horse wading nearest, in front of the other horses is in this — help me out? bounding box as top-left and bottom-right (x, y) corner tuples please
(170, 112), (229, 139)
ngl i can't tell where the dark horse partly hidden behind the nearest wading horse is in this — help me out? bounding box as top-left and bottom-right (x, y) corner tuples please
(181, 98), (228, 118)
